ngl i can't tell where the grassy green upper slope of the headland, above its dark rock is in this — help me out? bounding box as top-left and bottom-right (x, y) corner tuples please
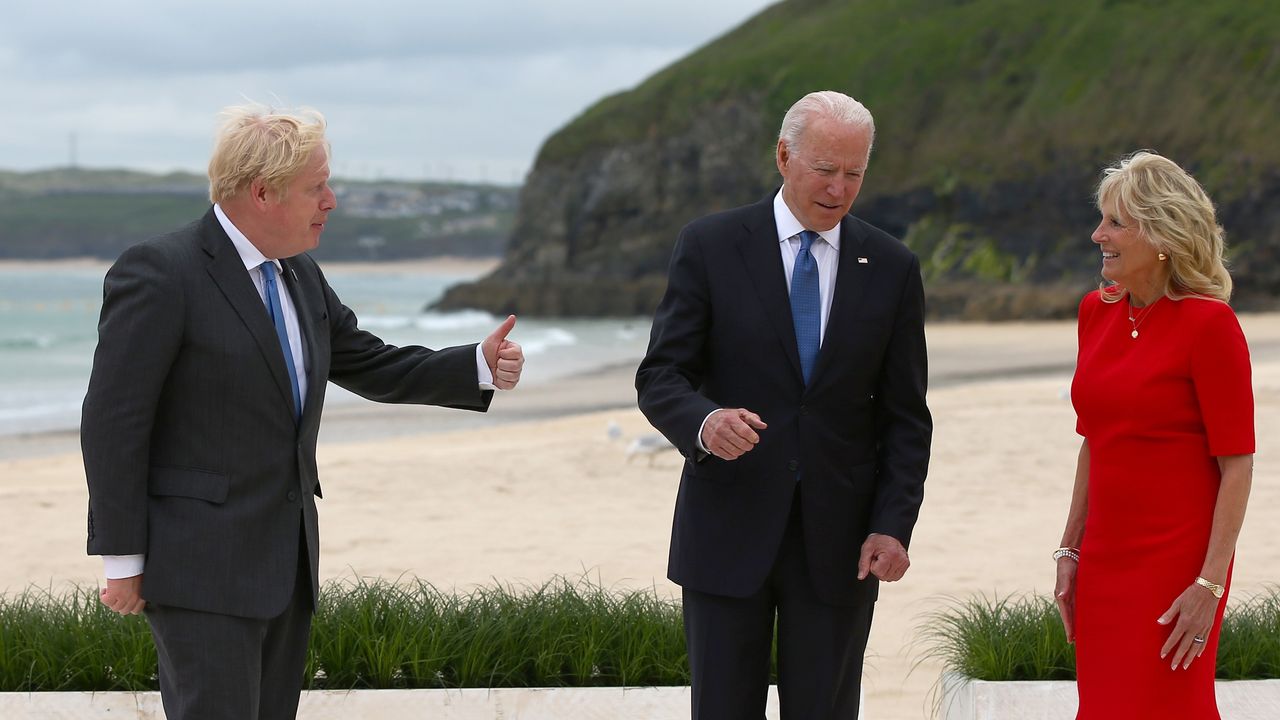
(540, 0), (1280, 193)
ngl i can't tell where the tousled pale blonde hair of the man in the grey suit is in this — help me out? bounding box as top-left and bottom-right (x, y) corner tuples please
(209, 105), (329, 202)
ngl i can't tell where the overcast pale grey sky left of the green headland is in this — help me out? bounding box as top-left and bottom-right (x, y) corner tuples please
(0, 0), (772, 183)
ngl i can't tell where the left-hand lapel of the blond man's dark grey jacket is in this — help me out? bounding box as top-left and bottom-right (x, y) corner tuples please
(200, 210), (293, 415)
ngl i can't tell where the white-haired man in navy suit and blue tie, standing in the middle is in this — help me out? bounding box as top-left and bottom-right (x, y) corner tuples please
(636, 91), (933, 720)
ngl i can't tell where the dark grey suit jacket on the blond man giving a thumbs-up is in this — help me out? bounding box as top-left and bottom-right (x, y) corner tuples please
(81, 209), (493, 618)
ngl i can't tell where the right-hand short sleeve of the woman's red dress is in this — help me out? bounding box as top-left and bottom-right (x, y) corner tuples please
(1192, 304), (1254, 457)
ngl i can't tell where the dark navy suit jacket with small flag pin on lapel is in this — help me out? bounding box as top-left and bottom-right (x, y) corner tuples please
(636, 196), (933, 605)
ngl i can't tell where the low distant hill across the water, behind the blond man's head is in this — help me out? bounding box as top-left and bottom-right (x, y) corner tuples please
(0, 168), (518, 260)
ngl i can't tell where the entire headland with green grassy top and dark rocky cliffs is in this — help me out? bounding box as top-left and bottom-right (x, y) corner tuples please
(445, 0), (1280, 316)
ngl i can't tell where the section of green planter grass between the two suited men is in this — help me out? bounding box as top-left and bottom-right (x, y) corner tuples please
(307, 578), (689, 689)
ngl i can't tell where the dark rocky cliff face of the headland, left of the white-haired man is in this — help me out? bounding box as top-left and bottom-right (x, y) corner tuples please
(442, 97), (769, 316)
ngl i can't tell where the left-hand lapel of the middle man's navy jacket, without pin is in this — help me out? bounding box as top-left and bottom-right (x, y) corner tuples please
(739, 196), (804, 378)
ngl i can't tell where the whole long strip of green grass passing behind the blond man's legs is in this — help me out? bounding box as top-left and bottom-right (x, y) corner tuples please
(0, 578), (689, 692)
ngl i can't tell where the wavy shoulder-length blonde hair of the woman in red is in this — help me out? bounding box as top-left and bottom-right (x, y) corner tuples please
(1097, 150), (1231, 302)
